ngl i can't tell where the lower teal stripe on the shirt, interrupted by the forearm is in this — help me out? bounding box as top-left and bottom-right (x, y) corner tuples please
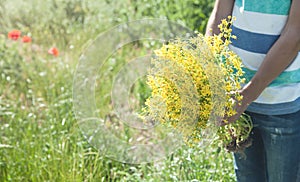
(243, 67), (300, 87)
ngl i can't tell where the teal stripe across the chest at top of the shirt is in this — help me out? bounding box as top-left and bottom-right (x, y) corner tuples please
(235, 0), (292, 15)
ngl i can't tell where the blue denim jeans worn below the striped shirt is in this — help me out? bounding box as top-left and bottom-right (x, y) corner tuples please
(234, 111), (300, 182)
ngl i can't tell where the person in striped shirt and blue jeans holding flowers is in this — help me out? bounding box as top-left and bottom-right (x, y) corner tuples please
(206, 0), (300, 182)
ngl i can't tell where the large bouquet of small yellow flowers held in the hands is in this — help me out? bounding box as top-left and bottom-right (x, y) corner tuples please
(144, 17), (253, 152)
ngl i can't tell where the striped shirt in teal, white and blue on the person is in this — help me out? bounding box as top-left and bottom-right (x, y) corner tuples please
(230, 0), (300, 115)
